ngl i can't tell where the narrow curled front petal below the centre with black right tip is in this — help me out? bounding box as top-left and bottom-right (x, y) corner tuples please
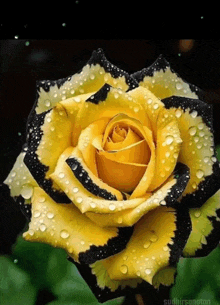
(86, 163), (189, 227)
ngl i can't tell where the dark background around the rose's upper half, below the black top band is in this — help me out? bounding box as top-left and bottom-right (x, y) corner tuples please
(0, 39), (220, 182)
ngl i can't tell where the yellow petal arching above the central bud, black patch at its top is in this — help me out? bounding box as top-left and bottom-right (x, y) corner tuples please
(73, 84), (149, 145)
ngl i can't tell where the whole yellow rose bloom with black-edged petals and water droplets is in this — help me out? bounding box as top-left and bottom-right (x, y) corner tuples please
(5, 49), (220, 302)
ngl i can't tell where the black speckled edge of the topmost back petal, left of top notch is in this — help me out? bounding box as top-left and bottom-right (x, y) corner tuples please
(87, 48), (139, 91)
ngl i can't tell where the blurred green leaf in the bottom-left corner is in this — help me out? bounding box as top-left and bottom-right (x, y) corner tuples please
(0, 256), (37, 305)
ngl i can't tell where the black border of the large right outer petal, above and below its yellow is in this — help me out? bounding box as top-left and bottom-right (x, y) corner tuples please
(162, 96), (220, 208)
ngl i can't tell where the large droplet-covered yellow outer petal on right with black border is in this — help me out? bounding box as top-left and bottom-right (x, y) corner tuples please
(163, 96), (220, 207)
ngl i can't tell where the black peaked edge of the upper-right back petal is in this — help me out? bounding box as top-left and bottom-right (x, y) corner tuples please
(131, 54), (206, 100)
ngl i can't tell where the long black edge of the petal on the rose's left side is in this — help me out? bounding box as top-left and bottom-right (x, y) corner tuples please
(24, 109), (71, 203)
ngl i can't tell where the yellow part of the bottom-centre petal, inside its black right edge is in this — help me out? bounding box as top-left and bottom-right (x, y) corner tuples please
(91, 207), (176, 289)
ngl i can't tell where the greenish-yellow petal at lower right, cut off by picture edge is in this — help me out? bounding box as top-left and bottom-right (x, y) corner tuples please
(183, 191), (220, 257)
